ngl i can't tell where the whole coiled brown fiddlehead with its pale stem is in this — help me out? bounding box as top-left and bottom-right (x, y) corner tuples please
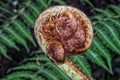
(34, 6), (93, 80)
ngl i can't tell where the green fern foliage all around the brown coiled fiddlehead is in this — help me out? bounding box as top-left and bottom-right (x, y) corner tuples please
(0, 0), (120, 80)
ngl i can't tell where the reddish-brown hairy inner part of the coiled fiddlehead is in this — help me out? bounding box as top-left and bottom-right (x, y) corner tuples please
(42, 11), (86, 61)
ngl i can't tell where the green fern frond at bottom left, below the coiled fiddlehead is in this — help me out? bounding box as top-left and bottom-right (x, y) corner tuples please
(3, 51), (70, 80)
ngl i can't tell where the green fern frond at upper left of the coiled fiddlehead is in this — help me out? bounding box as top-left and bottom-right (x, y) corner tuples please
(0, 0), (65, 59)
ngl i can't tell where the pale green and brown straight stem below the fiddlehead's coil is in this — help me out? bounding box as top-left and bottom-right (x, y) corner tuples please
(56, 60), (89, 80)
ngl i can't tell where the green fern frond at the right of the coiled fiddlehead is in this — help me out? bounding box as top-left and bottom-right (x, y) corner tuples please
(88, 5), (120, 74)
